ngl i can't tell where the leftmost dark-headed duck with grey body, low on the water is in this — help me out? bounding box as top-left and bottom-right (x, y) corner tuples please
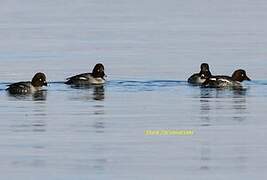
(6, 72), (47, 94)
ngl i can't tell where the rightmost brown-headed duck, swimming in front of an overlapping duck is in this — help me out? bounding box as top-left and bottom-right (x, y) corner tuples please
(203, 69), (250, 88)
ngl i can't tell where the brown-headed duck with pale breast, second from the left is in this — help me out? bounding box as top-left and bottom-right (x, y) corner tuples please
(65, 63), (106, 86)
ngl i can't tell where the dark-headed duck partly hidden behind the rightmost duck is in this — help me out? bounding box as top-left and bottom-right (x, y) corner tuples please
(187, 63), (214, 85)
